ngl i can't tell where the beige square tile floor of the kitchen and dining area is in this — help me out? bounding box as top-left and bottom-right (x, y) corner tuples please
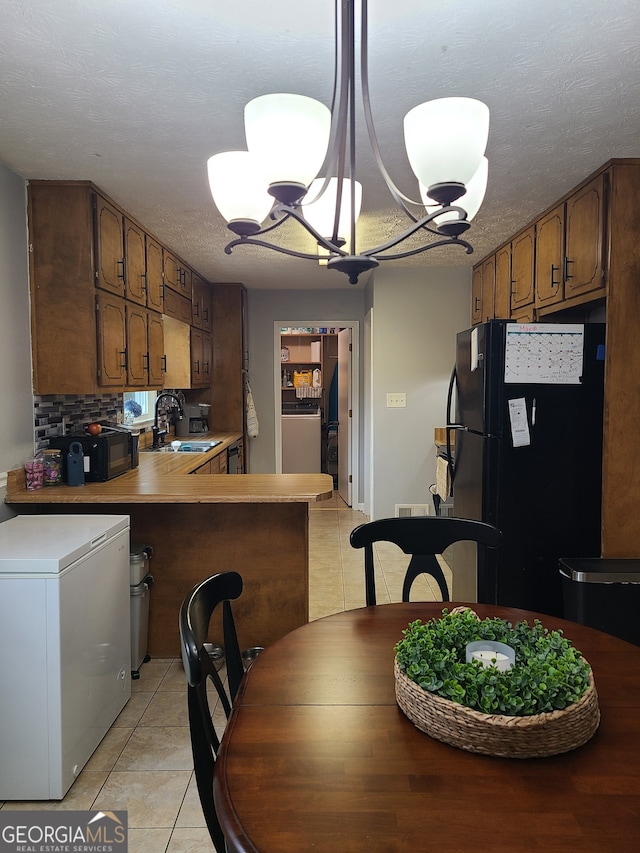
(0, 496), (450, 853)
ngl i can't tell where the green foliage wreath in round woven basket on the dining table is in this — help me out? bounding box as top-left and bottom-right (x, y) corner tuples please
(395, 608), (600, 758)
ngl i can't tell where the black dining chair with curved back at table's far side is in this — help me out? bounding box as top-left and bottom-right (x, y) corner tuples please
(349, 516), (502, 607)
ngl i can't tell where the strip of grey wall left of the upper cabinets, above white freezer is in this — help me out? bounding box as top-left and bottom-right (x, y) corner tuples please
(0, 164), (34, 520)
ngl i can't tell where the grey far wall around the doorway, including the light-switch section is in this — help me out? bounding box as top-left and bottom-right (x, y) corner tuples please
(248, 267), (471, 518)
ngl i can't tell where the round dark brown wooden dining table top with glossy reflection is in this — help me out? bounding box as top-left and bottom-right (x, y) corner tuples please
(214, 602), (640, 853)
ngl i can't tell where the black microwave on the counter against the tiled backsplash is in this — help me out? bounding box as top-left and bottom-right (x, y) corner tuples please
(49, 428), (138, 483)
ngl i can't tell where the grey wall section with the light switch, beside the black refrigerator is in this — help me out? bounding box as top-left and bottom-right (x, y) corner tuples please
(365, 267), (471, 518)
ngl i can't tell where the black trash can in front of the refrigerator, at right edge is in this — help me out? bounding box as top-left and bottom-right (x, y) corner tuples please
(560, 557), (640, 646)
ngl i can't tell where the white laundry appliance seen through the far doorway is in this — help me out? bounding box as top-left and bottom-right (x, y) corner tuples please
(282, 400), (322, 474)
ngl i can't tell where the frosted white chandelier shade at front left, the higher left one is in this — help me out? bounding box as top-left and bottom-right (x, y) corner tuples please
(244, 93), (331, 203)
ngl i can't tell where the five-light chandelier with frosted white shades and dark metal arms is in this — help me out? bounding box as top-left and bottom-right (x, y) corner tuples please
(207, 0), (489, 284)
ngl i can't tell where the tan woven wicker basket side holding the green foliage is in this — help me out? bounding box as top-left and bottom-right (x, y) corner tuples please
(394, 660), (600, 758)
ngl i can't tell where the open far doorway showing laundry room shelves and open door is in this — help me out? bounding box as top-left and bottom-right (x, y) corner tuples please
(273, 320), (360, 506)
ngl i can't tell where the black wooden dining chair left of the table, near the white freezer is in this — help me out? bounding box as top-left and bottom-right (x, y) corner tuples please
(180, 572), (244, 853)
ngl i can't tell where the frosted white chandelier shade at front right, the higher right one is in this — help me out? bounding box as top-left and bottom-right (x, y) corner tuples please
(404, 98), (489, 204)
